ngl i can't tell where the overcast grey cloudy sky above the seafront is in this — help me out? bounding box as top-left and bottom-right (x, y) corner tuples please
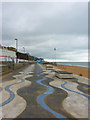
(2, 2), (88, 61)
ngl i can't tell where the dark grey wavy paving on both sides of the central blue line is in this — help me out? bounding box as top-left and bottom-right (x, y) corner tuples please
(18, 65), (74, 118)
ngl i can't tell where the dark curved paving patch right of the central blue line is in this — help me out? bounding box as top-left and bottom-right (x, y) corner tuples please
(42, 78), (74, 119)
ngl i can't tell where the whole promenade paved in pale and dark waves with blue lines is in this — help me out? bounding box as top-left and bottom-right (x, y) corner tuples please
(0, 64), (90, 120)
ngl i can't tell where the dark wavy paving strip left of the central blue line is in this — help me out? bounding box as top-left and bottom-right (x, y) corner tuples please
(18, 65), (54, 118)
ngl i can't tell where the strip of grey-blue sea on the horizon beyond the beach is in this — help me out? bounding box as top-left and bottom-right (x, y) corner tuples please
(57, 62), (90, 67)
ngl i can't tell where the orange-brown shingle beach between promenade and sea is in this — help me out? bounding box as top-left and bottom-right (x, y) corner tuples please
(55, 65), (90, 78)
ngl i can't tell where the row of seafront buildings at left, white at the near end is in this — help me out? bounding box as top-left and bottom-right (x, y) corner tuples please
(0, 45), (43, 63)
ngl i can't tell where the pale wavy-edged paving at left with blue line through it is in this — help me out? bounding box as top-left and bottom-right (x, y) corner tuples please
(0, 73), (32, 118)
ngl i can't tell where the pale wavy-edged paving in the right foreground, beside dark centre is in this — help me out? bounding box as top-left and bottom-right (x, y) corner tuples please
(49, 79), (88, 118)
